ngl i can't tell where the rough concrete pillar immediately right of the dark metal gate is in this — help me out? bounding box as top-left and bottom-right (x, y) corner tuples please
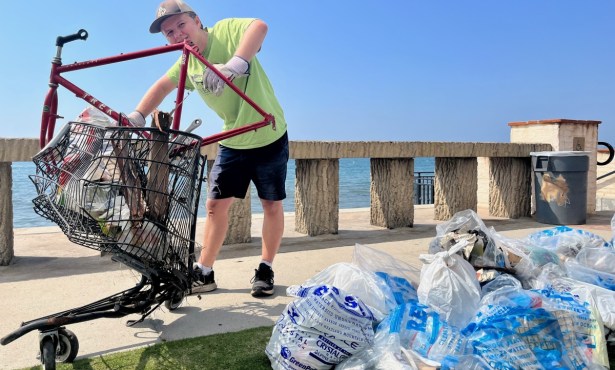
(434, 157), (478, 221)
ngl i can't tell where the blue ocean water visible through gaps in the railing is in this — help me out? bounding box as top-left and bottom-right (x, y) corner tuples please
(12, 157), (435, 228)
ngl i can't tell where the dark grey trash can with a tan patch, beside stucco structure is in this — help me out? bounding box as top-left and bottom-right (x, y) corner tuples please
(530, 151), (590, 225)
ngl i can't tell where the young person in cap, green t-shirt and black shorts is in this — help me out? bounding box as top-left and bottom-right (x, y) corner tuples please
(128, 0), (288, 297)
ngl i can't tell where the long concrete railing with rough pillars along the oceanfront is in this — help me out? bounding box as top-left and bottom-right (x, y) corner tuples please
(0, 138), (552, 265)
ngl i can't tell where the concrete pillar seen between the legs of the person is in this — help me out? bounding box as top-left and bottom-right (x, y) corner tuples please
(203, 160), (252, 245)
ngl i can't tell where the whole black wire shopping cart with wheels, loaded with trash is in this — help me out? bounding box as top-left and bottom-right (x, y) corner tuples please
(0, 122), (205, 368)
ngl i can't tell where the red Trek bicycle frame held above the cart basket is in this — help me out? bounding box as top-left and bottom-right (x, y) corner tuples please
(39, 29), (275, 149)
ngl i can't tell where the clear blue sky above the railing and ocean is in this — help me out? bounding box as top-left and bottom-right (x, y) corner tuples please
(0, 0), (615, 143)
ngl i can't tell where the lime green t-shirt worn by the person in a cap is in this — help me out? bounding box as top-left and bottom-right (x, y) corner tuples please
(167, 18), (286, 149)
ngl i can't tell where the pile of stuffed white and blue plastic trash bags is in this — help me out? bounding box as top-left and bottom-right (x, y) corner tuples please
(265, 210), (615, 370)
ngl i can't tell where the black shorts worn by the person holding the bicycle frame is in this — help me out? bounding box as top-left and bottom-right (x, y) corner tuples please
(207, 133), (288, 200)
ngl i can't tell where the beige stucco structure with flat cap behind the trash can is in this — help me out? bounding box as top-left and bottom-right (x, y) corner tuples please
(508, 118), (601, 214)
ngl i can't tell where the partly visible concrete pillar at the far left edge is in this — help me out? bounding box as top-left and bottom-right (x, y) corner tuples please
(0, 162), (15, 266)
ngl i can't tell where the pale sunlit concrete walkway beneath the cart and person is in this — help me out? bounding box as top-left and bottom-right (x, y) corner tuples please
(0, 206), (612, 369)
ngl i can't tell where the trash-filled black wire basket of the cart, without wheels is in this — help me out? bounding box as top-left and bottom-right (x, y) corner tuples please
(31, 122), (204, 275)
